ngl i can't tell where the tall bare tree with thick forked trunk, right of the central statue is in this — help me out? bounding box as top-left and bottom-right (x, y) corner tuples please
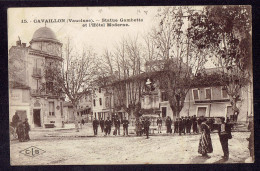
(151, 7), (206, 117)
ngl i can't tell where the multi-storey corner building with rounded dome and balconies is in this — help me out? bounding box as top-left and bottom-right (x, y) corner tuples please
(9, 27), (64, 127)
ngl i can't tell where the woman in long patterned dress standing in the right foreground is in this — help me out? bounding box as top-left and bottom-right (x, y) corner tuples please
(198, 120), (213, 156)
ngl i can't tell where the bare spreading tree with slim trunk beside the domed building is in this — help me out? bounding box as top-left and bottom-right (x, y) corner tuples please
(44, 39), (96, 131)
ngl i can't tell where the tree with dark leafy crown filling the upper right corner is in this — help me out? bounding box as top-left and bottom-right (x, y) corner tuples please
(191, 6), (252, 121)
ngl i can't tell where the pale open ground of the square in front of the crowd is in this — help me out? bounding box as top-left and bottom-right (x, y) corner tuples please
(10, 124), (252, 165)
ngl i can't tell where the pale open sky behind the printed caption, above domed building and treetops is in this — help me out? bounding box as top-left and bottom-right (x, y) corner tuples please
(8, 6), (215, 67)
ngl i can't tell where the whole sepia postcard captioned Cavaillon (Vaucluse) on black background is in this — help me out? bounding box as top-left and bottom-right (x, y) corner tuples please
(8, 5), (254, 165)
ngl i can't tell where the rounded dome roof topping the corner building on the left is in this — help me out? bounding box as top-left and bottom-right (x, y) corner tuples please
(32, 27), (59, 42)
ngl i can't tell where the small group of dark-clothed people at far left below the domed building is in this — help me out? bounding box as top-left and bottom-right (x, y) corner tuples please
(12, 112), (30, 142)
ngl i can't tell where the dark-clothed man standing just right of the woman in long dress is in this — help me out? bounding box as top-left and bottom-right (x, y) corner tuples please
(218, 118), (232, 160)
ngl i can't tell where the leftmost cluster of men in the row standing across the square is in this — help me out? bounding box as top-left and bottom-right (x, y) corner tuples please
(93, 117), (129, 136)
